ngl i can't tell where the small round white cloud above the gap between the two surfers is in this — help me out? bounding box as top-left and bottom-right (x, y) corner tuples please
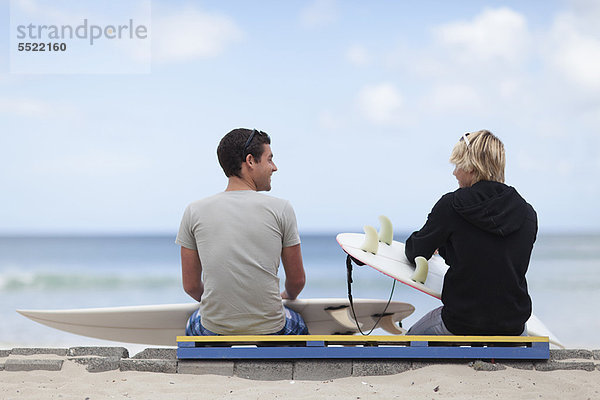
(358, 83), (404, 125)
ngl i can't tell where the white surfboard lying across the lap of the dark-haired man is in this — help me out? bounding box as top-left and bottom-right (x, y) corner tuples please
(17, 298), (415, 346)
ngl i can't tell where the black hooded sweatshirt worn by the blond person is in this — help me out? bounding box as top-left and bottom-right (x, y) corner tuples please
(406, 181), (537, 335)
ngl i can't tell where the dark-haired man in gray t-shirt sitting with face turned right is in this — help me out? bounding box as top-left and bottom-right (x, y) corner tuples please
(176, 129), (308, 335)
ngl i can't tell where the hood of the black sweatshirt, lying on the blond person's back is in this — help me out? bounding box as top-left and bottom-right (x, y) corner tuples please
(452, 181), (529, 236)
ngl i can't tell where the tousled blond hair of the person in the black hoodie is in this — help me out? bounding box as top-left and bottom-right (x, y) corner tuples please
(450, 130), (506, 183)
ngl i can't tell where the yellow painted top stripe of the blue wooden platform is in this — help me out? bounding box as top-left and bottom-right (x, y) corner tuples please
(177, 335), (548, 343)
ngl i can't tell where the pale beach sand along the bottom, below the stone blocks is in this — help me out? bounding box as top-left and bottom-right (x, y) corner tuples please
(0, 361), (600, 400)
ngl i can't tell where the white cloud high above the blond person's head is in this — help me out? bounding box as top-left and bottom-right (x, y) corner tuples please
(434, 8), (530, 64)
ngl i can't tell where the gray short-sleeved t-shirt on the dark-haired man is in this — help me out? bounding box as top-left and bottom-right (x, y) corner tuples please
(176, 190), (300, 335)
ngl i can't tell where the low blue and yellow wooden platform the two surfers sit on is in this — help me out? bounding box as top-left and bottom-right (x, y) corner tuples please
(177, 335), (550, 360)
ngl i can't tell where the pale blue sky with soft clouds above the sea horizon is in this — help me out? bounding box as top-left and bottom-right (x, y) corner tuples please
(0, 0), (600, 235)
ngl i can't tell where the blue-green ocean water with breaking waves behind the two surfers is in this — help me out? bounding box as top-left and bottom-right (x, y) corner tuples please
(0, 234), (600, 351)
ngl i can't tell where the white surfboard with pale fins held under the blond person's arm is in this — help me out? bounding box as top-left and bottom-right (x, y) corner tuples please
(336, 233), (564, 348)
